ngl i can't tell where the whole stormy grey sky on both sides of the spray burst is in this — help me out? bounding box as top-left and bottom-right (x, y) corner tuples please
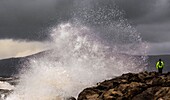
(0, 0), (170, 58)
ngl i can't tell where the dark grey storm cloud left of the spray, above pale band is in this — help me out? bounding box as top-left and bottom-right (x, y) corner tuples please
(0, 0), (72, 40)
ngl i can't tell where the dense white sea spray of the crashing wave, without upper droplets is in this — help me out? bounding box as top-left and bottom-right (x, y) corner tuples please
(7, 23), (144, 100)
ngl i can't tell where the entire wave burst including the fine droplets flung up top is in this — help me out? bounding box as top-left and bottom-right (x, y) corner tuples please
(6, 0), (147, 100)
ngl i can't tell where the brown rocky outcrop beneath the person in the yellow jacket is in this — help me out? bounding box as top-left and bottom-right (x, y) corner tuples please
(78, 72), (170, 100)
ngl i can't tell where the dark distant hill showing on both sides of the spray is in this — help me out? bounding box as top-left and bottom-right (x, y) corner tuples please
(0, 50), (170, 77)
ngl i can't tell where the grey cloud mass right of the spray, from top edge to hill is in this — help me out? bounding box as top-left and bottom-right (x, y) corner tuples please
(117, 0), (170, 45)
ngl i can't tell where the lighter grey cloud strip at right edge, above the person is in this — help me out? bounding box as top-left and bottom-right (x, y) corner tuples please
(136, 21), (170, 43)
